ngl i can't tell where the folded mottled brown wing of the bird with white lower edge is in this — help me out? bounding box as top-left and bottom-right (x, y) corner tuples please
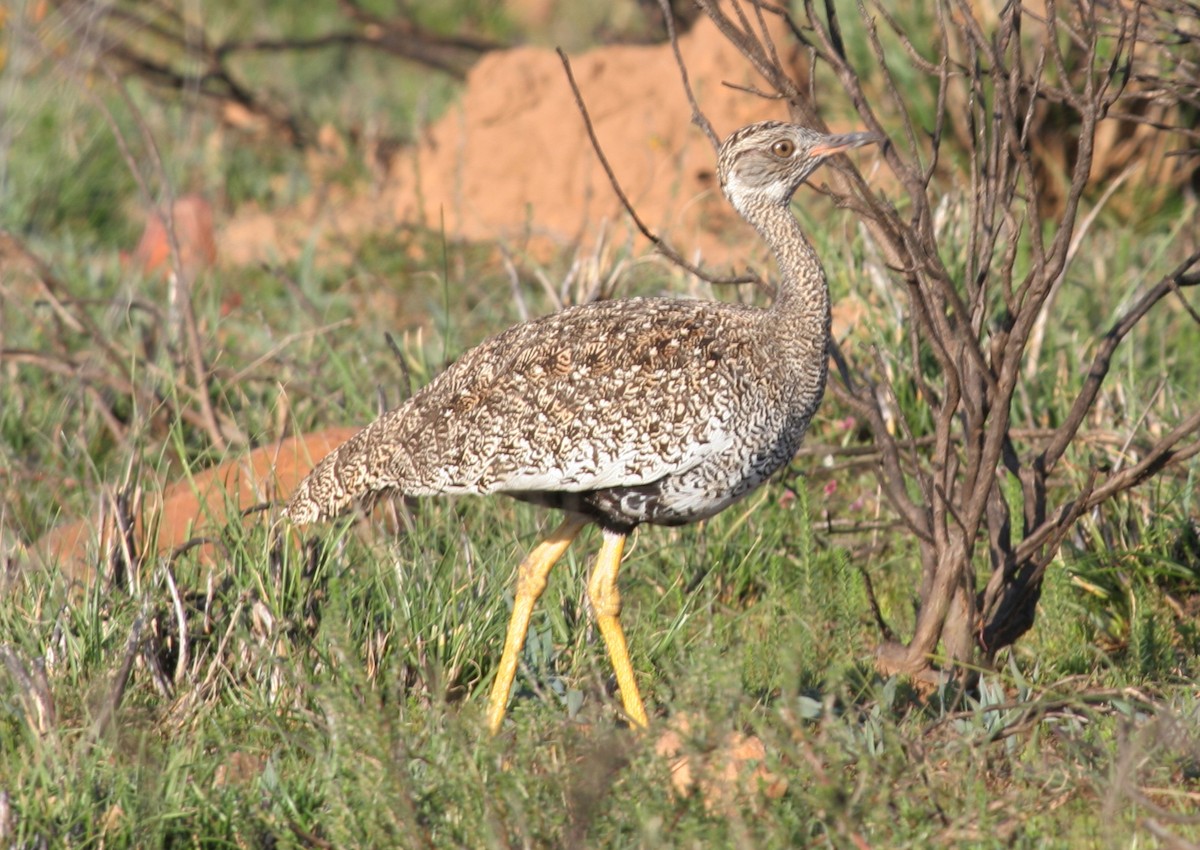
(391, 299), (752, 495)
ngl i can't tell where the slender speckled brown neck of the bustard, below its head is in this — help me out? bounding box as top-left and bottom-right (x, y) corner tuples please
(745, 204), (830, 352)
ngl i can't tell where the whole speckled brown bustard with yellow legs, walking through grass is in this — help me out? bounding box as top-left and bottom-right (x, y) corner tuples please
(284, 121), (880, 735)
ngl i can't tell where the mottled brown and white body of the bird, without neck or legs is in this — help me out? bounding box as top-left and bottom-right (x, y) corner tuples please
(288, 299), (815, 526)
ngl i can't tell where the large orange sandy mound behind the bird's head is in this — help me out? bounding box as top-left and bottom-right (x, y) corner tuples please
(221, 19), (806, 272)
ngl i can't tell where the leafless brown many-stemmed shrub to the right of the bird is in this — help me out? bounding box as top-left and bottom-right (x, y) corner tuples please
(700, 0), (1200, 678)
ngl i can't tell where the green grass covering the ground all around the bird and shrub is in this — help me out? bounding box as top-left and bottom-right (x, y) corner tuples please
(0, 4), (1200, 848)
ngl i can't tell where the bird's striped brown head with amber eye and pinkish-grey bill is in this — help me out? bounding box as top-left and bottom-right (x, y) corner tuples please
(716, 121), (880, 215)
